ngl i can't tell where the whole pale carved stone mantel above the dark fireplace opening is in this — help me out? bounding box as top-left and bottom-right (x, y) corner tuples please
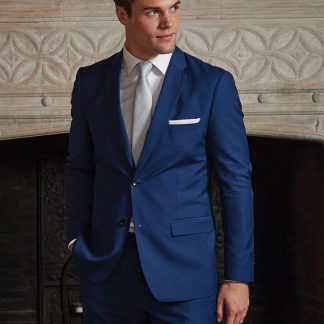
(0, 0), (324, 142)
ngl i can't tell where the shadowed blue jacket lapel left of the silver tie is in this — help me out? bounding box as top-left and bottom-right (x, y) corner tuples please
(106, 51), (134, 167)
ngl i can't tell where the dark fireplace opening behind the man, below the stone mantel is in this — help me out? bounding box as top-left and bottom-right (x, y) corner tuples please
(0, 135), (324, 324)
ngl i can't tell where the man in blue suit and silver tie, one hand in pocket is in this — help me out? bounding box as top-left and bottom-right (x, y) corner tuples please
(65, 0), (254, 324)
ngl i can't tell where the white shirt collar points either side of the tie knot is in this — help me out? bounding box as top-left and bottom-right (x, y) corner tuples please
(123, 45), (172, 76)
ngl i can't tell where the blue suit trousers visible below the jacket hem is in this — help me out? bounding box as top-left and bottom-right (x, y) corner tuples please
(76, 234), (216, 324)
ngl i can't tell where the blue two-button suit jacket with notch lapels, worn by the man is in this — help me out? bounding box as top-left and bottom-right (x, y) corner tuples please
(65, 48), (254, 301)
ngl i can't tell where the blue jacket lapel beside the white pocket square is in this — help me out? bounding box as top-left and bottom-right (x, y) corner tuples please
(137, 48), (187, 169)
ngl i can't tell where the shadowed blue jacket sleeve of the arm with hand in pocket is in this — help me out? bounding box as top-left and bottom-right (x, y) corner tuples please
(64, 69), (95, 246)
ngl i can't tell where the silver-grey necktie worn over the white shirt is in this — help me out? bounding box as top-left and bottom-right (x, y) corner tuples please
(132, 61), (152, 165)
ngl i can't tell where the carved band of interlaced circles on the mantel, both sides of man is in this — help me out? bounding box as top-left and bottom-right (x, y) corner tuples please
(0, 26), (324, 91)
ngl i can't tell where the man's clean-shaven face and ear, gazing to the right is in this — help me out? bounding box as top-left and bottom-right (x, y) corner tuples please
(116, 0), (180, 60)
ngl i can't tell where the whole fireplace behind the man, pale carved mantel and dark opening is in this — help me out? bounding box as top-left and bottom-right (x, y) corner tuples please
(0, 0), (324, 324)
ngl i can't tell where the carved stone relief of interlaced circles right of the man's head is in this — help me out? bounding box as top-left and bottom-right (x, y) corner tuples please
(179, 26), (324, 88)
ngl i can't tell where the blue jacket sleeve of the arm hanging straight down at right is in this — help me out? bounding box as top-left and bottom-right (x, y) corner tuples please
(207, 71), (254, 281)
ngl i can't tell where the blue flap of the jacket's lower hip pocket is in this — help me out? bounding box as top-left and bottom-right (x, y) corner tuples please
(171, 216), (214, 236)
